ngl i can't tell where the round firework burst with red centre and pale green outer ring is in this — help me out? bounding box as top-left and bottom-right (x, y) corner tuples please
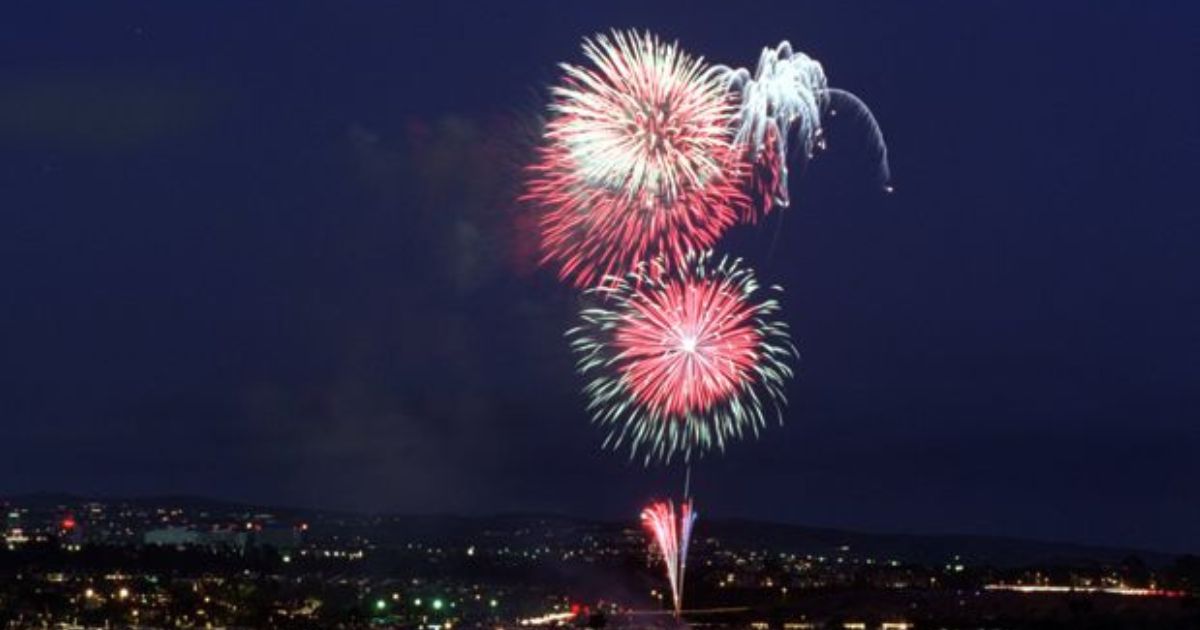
(566, 253), (796, 463)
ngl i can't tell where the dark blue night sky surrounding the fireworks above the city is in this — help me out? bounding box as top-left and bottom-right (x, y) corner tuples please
(0, 1), (1200, 552)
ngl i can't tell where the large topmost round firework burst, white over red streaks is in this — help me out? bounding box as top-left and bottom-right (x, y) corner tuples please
(523, 31), (750, 287)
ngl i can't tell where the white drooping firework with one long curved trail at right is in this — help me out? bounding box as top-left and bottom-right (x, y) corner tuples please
(710, 41), (892, 211)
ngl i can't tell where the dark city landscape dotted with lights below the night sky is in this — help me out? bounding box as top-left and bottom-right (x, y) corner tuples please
(0, 496), (1200, 630)
